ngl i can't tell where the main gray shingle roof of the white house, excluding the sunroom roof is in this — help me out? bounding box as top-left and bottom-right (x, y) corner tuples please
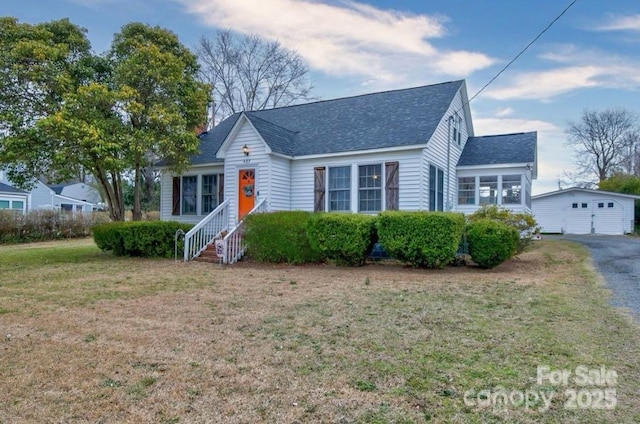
(191, 80), (464, 160)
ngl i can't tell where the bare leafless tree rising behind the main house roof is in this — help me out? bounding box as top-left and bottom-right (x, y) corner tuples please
(197, 30), (313, 125)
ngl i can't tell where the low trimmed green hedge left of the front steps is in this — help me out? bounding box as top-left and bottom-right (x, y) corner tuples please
(93, 221), (193, 258)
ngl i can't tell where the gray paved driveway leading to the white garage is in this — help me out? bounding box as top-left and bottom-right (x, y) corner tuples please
(547, 234), (640, 320)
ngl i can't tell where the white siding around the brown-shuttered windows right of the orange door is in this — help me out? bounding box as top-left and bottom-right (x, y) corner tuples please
(291, 149), (424, 212)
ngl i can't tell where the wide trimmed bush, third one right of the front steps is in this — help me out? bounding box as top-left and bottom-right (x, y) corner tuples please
(377, 211), (465, 268)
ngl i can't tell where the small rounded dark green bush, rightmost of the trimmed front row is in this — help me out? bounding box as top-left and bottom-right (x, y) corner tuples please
(467, 219), (520, 268)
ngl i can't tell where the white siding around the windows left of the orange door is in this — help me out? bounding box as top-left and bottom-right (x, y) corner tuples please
(160, 163), (226, 224)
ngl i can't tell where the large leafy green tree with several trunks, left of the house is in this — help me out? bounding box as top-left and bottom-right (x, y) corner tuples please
(0, 18), (208, 220)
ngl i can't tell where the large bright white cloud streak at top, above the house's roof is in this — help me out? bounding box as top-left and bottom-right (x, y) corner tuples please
(174, 0), (494, 85)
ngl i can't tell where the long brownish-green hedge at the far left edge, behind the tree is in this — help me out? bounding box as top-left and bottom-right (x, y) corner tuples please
(0, 210), (109, 243)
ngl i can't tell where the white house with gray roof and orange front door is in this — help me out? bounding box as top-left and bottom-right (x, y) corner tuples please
(160, 81), (537, 260)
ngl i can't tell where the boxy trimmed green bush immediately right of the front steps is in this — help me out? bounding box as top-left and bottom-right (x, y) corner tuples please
(245, 211), (322, 264)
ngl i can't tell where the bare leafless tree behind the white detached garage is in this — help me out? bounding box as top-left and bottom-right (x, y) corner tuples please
(566, 108), (638, 182)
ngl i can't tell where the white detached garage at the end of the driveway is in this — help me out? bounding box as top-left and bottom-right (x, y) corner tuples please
(531, 188), (640, 234)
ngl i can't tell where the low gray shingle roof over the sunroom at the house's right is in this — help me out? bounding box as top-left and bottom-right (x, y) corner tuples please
(458, 131), (538, 166)
